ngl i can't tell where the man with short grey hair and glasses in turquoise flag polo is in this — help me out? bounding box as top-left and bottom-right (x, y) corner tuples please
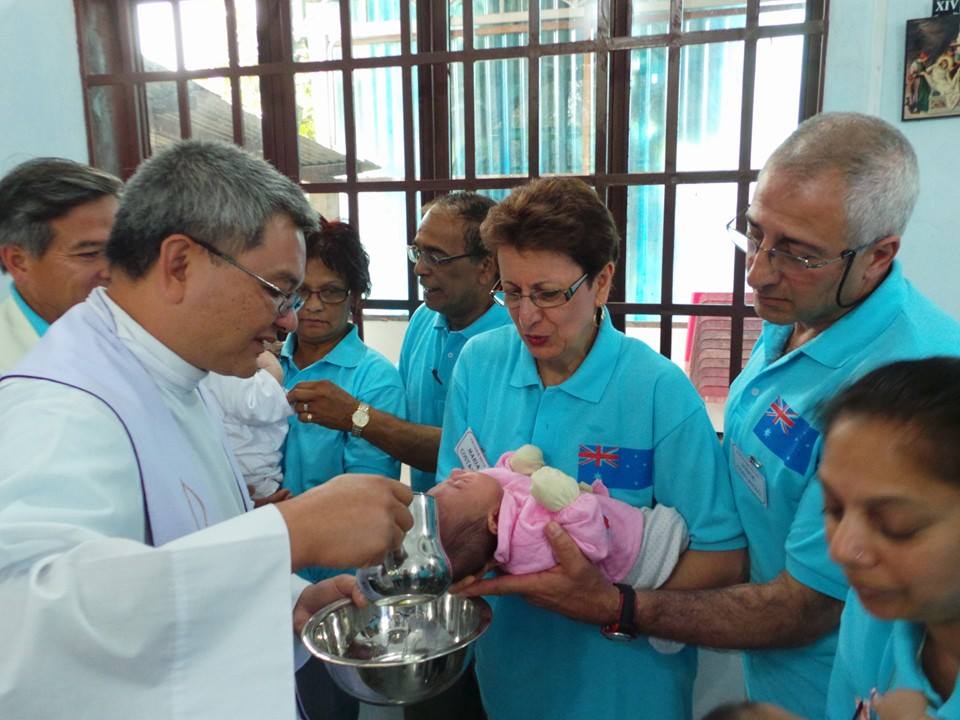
(568, 113), (960, 718)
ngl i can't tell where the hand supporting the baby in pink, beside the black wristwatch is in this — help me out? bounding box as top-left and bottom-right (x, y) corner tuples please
(456, 522), (620, 625)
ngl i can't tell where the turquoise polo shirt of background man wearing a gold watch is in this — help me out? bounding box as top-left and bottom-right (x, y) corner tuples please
(398, 303), (511, 492)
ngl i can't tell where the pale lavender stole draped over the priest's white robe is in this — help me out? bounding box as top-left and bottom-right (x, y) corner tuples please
(0, 293), (252, 546)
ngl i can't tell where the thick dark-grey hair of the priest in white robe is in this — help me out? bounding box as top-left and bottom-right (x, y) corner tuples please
(107, 140), (317, 279)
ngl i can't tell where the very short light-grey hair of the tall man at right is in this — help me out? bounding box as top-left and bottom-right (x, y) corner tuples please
(763, 113), (920, 248)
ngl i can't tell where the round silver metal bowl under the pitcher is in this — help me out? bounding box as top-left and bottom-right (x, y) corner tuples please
(300, 593), (493, 705)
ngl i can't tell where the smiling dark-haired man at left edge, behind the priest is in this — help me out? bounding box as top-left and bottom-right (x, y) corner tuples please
(0, 158), (123, 372)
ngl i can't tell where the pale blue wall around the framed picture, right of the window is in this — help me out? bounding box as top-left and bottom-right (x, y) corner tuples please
(823, 0), (960, 318)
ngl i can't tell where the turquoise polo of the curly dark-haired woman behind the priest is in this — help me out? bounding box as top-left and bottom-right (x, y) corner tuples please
(280, 327), (406, 582)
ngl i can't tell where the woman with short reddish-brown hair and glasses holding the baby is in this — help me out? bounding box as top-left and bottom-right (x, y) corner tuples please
(437, 178), (744, 720)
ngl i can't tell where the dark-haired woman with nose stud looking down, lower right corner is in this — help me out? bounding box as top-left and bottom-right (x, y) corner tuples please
(819, 357), (960, 720)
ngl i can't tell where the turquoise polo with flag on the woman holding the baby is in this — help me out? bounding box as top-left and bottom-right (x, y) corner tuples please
(437, 318), (745, 720)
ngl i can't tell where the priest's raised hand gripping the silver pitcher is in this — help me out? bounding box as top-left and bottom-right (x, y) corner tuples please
(274, 474), (413, 570)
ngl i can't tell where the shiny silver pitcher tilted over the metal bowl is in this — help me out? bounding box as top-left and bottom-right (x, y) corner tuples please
(357, 493), (452, 604)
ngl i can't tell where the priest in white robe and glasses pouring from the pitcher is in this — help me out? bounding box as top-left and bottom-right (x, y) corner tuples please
(0, 141), (412, 718)
